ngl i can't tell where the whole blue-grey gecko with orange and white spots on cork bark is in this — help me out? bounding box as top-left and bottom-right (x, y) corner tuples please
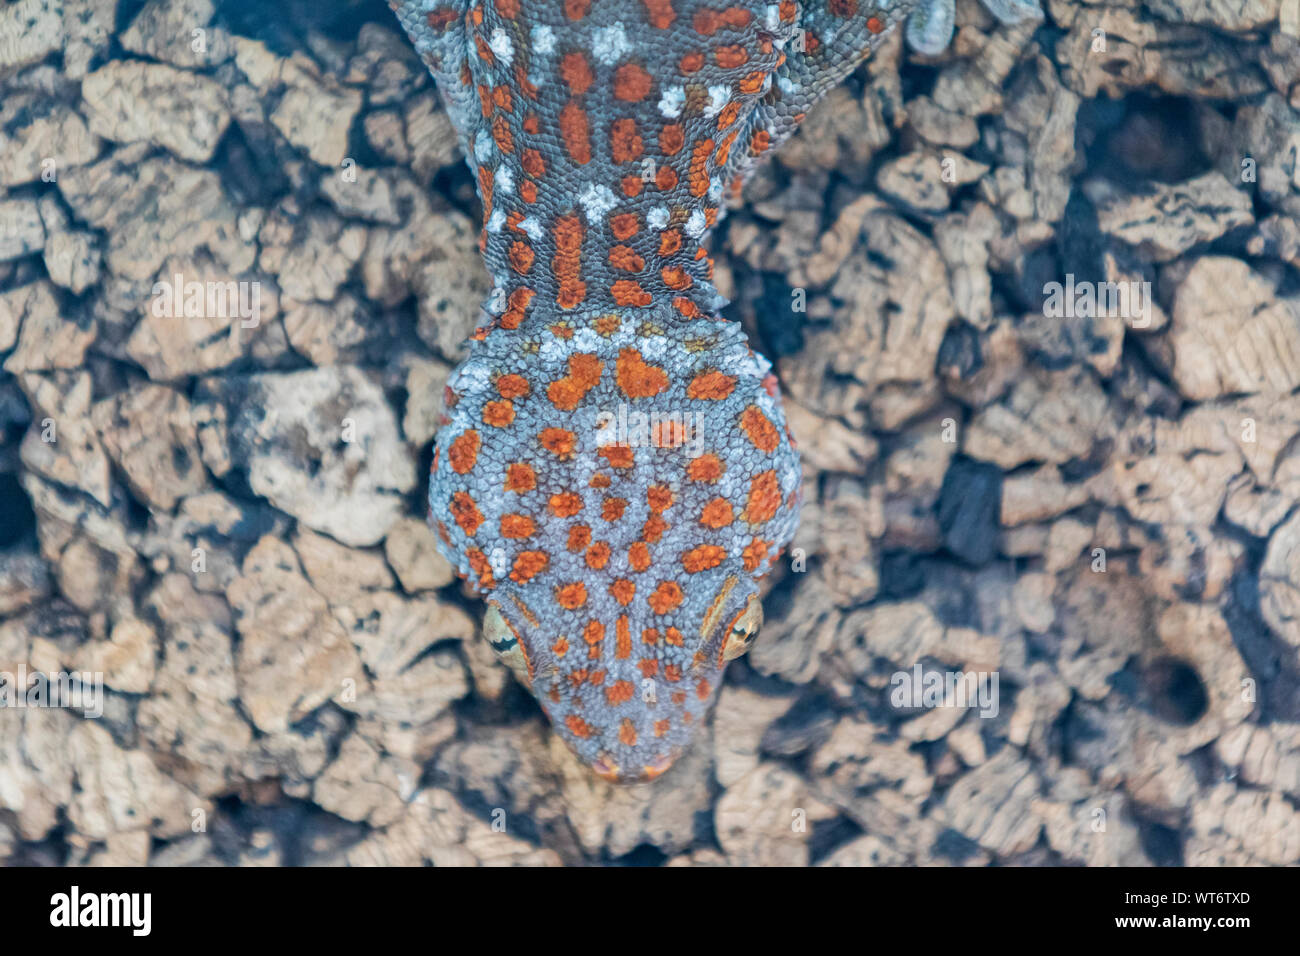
(390, 0), (1036, 783)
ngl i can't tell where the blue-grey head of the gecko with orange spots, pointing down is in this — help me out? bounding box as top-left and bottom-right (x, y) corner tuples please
(429, 315), (800, 783)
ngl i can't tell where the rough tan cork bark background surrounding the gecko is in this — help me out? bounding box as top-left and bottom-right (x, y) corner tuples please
(0, 0), (1300, 865)
